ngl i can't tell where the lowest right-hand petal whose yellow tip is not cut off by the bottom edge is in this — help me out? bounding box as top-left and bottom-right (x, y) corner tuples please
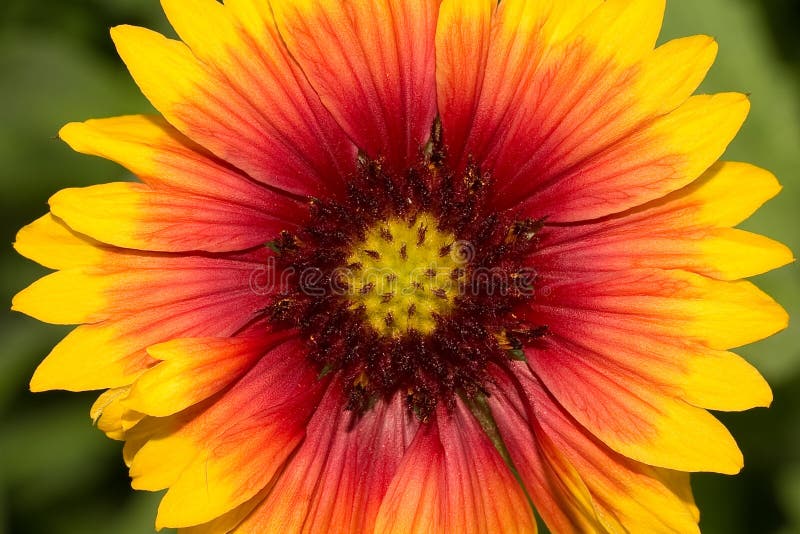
(527, 340), (742, 474)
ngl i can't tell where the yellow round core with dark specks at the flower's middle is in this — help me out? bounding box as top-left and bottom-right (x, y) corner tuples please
(344, 214), (469, 337)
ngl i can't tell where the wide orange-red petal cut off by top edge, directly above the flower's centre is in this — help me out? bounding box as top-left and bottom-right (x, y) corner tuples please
(270, 0), (439, 170)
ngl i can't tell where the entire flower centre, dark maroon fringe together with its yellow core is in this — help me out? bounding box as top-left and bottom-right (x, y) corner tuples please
(265, 129), (544, 421)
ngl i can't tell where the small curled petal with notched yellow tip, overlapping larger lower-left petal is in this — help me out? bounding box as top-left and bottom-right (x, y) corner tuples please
(123, 333), (294, 417)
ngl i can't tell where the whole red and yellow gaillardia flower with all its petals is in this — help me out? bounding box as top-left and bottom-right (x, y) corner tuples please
(14, 0), (792, 534)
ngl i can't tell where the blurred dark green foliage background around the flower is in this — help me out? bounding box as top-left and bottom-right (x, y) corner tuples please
(0, 0), (800, 534)
